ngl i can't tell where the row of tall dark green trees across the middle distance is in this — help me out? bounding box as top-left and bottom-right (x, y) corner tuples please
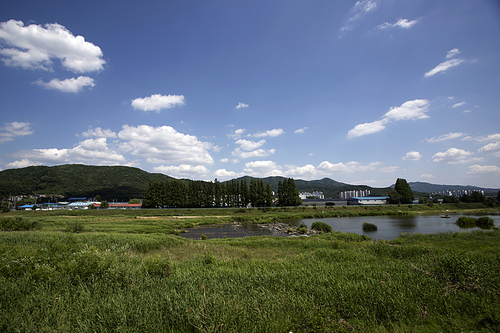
(142, 178), (302, 208)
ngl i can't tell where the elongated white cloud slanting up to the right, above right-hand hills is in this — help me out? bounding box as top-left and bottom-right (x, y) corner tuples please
(347, 99), (429, 139)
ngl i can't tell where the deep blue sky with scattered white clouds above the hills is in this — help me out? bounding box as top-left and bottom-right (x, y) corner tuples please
(0, 0), (500, 188)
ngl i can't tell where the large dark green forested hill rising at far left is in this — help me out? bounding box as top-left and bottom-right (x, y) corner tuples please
(0, 164), (173, 201)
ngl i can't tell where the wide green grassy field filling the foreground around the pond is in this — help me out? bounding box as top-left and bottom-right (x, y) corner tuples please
(0, 207), (500, 332)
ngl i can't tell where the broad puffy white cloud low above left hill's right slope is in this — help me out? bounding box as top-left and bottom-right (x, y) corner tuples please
(118, 125), (214, 165)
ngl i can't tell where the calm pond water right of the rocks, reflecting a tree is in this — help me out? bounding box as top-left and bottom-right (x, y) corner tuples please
(286, 214), (500, 240)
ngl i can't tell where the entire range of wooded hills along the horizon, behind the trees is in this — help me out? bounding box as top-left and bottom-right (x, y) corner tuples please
(0, 164), (498, 201)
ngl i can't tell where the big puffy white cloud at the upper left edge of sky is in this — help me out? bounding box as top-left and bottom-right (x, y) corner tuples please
(0, 20), (106, 73)
